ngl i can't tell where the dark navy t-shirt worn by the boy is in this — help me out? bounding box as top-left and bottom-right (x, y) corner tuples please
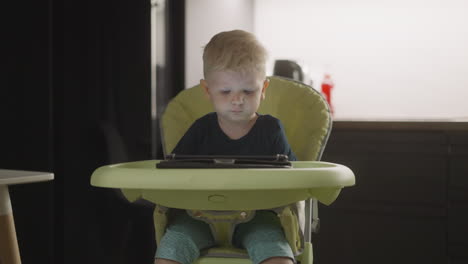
(172, 112), (297, 160)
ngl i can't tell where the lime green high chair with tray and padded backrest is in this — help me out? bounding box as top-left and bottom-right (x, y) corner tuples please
(91, 77), (355, 264)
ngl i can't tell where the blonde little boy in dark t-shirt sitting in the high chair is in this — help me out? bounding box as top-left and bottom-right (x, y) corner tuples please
(155, 30), (296, 264)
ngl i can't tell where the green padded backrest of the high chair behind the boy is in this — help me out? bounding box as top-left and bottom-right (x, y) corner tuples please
(161, 76), (332, 160)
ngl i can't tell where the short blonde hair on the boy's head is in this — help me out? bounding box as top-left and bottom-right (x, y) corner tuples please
(203, 30), (268, 78)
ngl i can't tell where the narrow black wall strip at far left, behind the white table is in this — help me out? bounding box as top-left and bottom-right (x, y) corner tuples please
(0, 1), (55, 263)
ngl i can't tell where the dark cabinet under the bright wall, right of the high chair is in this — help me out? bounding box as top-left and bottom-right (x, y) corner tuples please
(313, 123), (468, 264)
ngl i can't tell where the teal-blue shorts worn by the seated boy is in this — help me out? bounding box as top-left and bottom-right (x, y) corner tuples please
(156, 211), (294, 264)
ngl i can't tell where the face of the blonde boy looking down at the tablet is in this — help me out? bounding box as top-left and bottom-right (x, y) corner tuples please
(200, 71), (268, 122)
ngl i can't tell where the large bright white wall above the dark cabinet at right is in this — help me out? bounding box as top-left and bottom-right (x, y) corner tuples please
(254, 0), (468, 119)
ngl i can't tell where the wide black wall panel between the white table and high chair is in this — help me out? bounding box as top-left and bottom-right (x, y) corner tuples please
(60, 1), (152, 263)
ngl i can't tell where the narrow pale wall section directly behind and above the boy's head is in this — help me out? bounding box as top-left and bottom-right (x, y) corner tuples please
(185, 0), (253, 88)
